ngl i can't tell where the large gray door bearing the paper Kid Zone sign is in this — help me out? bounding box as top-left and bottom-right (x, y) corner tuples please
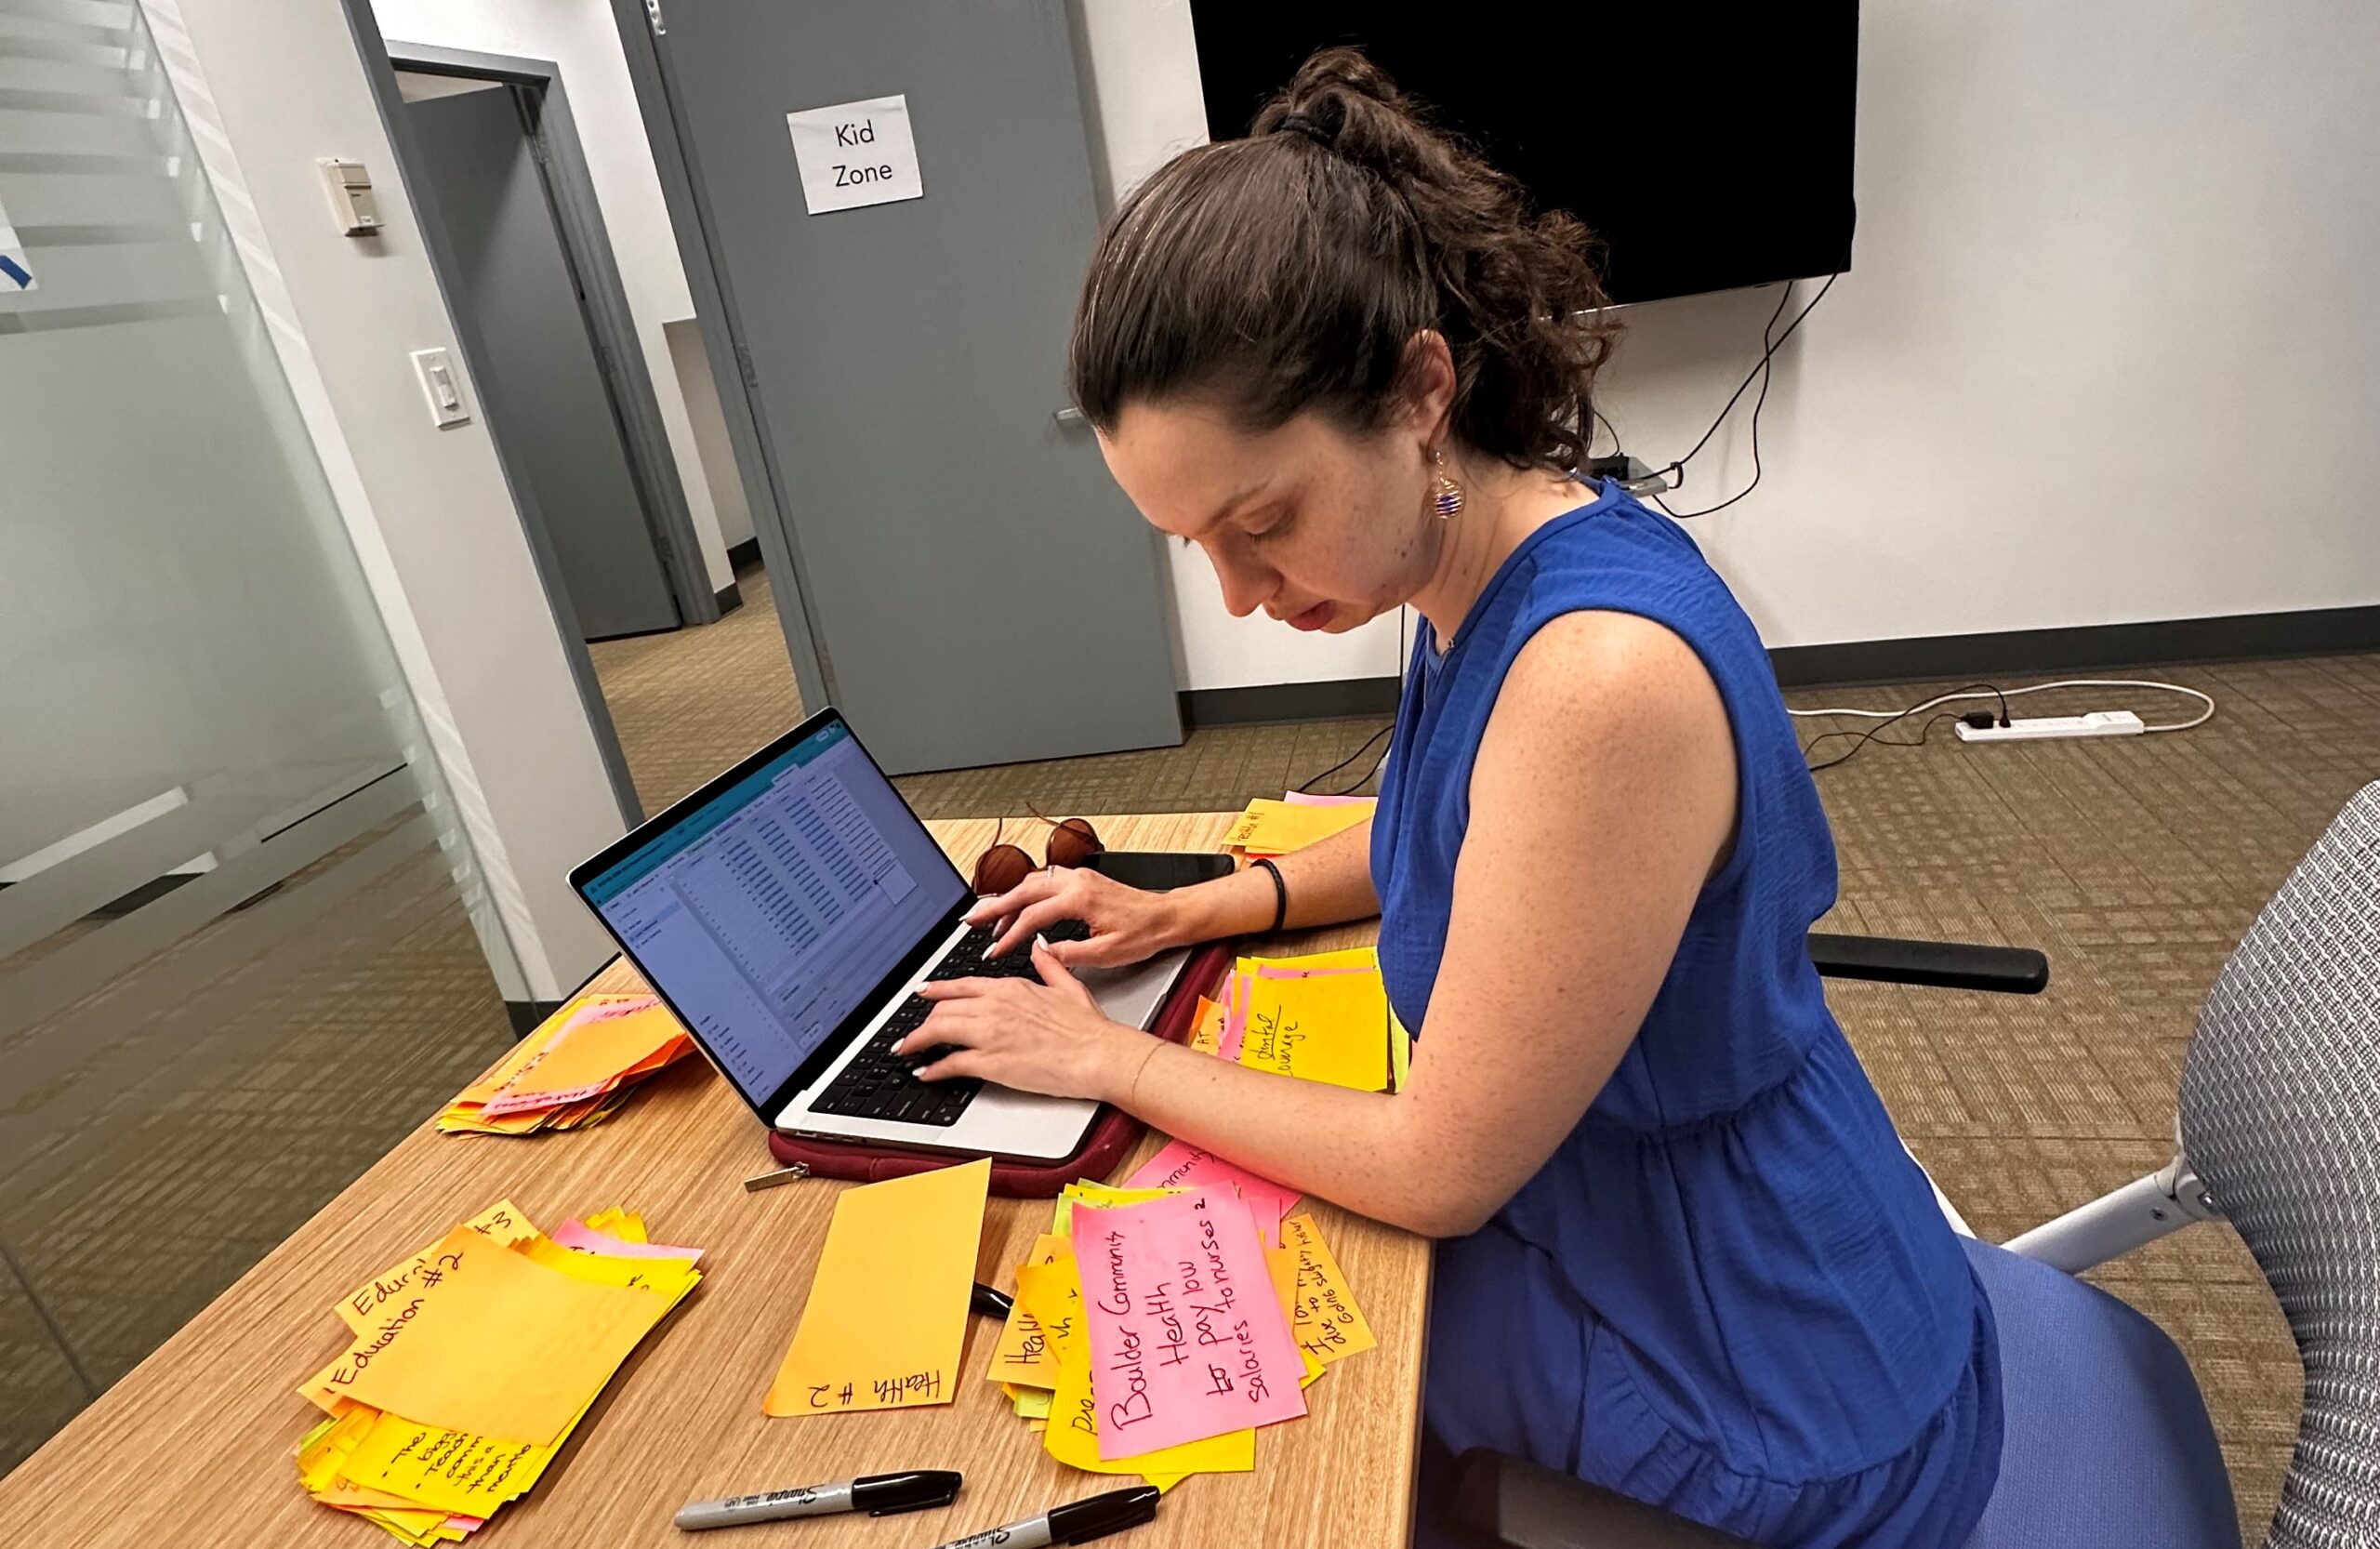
(657, 0), (1181, 771)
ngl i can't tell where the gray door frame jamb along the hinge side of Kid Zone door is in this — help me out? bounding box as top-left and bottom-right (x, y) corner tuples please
(600, 0), (836, 714)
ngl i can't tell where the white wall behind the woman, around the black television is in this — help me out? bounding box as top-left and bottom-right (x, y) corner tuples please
(1083, 0), (2380, 688)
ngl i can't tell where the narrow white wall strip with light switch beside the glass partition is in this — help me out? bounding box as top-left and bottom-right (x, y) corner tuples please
(148, 0), (621, 1000)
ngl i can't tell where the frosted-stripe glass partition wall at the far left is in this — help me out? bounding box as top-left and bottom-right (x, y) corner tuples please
(0, 0), (519, 1471)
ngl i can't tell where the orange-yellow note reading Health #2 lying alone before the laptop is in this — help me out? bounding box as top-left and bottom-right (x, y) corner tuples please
(761, 1158), (993, 1416)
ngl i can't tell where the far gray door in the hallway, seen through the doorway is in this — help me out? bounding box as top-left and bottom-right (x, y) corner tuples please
(404, 86), (679, 640)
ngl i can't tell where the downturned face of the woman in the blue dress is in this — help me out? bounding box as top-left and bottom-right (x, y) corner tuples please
(1100, 400), (1445, 633)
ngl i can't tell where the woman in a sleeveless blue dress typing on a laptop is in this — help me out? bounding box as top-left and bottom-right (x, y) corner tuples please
(909, 50), (1999, 1546)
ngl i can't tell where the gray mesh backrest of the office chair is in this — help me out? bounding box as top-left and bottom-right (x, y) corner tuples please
(2183, 783), (2380, 1549)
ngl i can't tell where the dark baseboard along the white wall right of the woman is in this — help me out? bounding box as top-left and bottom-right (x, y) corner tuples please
(1768, 607), (2380, 688)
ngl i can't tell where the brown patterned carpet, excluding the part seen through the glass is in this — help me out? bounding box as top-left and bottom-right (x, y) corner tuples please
(598, 576), (2380, 1544)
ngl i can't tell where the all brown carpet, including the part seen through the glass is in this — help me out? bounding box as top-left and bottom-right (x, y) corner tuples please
(14, 551), (2380, 1542)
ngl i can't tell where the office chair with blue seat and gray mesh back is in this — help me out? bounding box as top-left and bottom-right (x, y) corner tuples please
(1440, 783), (2380, 1549)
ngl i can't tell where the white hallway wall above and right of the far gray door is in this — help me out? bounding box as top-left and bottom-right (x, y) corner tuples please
(371, 0), (735, 588)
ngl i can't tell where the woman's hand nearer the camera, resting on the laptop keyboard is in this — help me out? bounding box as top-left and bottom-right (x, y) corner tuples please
(895, 937), (1149, 1102)
